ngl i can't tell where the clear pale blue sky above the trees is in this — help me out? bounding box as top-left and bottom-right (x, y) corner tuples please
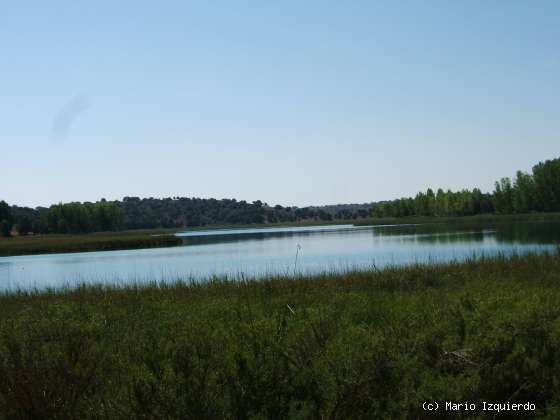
(0, 0), (560, 207)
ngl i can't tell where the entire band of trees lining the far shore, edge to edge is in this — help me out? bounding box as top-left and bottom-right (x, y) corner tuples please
(0, 159), (560, 236)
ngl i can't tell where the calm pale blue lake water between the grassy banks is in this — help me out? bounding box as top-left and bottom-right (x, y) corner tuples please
(0, 222), (560, 292)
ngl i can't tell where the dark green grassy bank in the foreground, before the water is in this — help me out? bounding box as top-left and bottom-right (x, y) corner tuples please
(0, 253), (560, 419)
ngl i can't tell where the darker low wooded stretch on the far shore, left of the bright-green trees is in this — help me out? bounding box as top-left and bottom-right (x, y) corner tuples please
(0, 197), (371, 236)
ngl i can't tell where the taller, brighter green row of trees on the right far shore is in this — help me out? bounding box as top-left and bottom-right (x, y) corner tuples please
(373, 159), (560, 217)
